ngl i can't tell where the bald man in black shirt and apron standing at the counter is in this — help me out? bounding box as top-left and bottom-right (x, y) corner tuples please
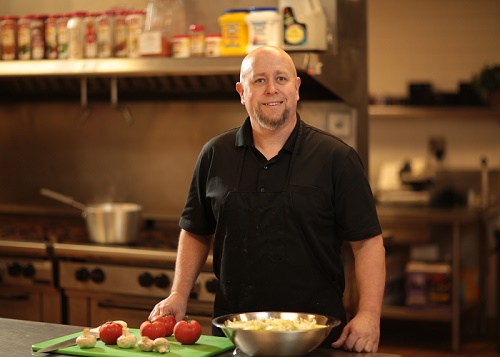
(151, 46), (385, 352)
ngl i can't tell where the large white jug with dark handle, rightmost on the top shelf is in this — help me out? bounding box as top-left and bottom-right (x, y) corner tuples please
(279, 0), (327, 51)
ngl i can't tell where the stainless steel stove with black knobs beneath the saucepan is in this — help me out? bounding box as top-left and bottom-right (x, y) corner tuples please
(0, 215), (218, 334)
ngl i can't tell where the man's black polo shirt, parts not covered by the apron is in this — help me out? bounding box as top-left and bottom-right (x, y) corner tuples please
(179, 117), (381, 245)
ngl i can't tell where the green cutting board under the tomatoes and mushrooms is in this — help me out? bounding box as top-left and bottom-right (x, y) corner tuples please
(31, 328), (234, 357)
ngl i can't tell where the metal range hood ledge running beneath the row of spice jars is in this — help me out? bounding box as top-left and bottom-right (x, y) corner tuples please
(0, 52), (340, 101)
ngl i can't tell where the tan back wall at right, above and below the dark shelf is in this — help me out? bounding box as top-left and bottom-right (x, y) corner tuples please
(367, 0), (500, 183)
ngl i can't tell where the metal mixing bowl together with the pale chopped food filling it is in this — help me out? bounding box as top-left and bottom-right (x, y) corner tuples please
(212, 311), (340, 357)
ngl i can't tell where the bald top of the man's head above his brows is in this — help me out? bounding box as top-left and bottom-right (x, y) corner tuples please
(240, 46), (297, 82)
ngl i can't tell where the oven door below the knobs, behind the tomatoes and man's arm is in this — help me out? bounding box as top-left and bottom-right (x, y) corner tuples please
(65, 290), (212, 335)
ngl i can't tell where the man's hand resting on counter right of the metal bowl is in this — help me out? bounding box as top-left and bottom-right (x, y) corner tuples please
(332, 312), (380, 353)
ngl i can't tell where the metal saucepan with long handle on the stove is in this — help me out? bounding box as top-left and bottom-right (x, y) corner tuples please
(40, 188), (142, 244)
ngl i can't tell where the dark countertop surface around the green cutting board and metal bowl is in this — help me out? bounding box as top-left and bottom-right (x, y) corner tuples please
(0, 318), (398, 357)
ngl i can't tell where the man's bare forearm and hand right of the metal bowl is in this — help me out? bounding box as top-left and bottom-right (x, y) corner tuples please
(332, 235), (385, 352)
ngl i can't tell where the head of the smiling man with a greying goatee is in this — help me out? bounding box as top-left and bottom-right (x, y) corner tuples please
(236, 46), (300, 130)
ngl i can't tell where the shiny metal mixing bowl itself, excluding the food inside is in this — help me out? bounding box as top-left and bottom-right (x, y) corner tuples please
(212, 312), (340, 357)
